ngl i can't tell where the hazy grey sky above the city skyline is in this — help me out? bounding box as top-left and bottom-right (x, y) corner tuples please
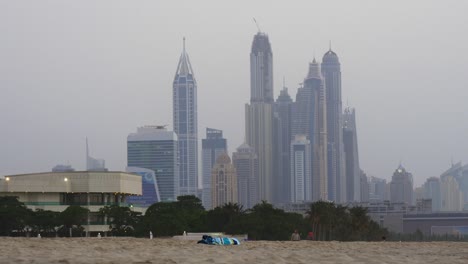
(0, 0), (468, 185)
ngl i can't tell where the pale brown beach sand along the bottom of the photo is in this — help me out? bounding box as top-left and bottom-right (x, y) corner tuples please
(0, 237), (468, 264)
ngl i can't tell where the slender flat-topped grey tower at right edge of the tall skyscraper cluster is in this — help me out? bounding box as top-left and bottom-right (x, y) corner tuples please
(342, 108), (361, 202)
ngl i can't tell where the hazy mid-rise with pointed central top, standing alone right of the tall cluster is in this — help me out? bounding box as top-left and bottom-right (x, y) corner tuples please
(390, 165), (414, 205)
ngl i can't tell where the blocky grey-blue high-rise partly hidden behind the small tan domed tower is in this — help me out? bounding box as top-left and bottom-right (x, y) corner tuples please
(202, 128), (227, 210)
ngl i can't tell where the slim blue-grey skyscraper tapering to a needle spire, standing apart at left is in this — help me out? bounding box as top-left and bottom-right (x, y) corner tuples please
(172, 38), (198, 195)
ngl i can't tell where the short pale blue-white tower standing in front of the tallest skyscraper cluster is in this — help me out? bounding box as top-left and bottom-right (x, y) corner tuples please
(290, 135), (313, 203)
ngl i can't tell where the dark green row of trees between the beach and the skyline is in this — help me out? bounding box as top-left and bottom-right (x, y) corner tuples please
(0, 195), (388, 241)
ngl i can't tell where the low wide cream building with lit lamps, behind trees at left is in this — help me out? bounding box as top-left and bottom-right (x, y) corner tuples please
(0, 171), (142, 234)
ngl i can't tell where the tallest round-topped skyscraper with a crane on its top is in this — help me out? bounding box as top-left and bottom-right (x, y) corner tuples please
(245, 32), (273, 202)
